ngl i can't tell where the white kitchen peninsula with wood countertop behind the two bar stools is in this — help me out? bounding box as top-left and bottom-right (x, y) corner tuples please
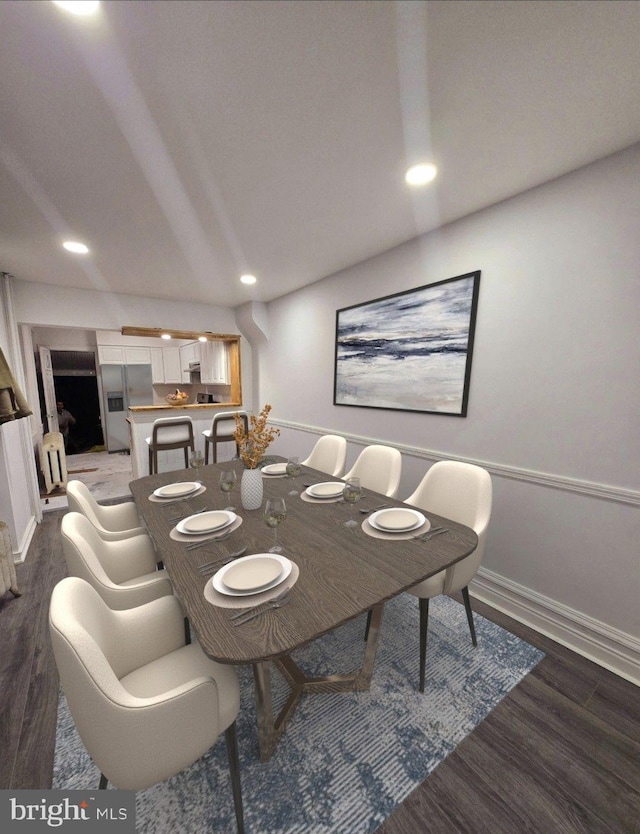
(127, 402), (244, 480)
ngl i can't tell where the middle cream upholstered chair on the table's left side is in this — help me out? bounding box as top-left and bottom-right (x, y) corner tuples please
(60, 512), (173, 609)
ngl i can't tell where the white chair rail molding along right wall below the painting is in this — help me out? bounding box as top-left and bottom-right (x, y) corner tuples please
(269, 419), (640, 507)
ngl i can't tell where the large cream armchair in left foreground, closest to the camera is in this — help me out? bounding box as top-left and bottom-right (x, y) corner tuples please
(49, 576), (244, 834)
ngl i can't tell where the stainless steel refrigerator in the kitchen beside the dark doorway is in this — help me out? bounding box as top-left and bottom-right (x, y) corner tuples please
(100, 365), (153, 452)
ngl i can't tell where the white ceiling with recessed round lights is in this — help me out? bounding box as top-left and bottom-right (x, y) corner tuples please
(0, 0), (640, 306)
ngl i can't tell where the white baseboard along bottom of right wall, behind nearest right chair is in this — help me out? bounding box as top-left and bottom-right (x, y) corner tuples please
(469, 568), (640, 686)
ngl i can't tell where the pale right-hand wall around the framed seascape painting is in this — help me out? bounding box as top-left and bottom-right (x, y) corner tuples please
(260, 146), (640, 676)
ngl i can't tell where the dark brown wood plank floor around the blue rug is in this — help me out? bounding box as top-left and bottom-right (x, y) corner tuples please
(0, 511), (640, 834)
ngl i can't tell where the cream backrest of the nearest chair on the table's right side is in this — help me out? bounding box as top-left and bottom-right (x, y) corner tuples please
(405, 460), (493, 594)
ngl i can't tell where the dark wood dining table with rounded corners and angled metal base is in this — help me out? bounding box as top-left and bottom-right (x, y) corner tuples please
(130, 458), (478, 761)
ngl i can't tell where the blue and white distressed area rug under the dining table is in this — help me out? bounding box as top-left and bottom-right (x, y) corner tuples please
(53, 594), (544, 834)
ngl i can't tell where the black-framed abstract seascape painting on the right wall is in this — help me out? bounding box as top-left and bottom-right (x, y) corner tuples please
(333, 270), (480, 417)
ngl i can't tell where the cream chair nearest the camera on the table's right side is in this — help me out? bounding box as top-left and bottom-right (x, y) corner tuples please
(405, 460), (493, 692)
